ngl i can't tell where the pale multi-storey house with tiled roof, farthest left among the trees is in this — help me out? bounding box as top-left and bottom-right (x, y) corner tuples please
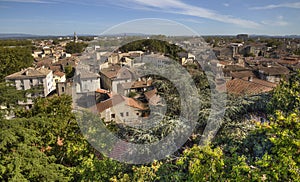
(5, 67), (55, 105)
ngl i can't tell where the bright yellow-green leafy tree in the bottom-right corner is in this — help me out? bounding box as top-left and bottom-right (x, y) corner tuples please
(254, 112), (300, 181)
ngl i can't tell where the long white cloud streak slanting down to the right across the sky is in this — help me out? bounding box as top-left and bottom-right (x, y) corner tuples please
(123, 0), (260, 28)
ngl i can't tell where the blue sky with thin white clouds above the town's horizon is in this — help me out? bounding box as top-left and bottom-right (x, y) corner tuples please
(0, 0), (300, 35)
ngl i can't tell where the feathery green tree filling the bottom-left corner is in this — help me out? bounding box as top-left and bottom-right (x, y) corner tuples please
(0, 118), (68, 181)
